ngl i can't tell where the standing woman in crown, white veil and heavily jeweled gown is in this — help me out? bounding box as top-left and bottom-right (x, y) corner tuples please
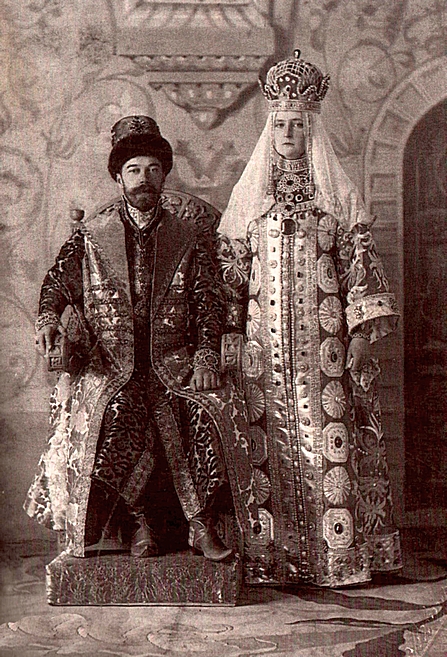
(220, 51), (401, 586)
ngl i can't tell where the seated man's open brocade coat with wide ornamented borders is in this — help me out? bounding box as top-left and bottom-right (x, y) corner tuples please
(25, 200), (257, 556)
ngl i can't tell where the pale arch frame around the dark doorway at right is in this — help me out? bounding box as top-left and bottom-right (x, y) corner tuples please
(364, 57), (447, 525)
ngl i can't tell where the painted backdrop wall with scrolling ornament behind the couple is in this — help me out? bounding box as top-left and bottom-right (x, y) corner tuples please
(0, 0), (446, 542)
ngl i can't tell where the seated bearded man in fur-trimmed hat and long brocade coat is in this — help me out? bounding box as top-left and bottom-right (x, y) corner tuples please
(25, 116), (257, 561)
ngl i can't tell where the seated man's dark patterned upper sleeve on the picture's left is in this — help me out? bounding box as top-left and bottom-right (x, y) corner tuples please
(38, 230), (84, 322)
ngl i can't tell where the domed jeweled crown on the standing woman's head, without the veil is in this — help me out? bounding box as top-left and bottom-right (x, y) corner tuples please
(259, 50), (330, 112)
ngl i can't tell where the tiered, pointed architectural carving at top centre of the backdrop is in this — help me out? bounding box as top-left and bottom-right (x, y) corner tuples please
(114, 0), (274, 129)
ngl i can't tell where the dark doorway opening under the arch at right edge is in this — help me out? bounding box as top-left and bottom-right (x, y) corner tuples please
(404, 101), (447, 511)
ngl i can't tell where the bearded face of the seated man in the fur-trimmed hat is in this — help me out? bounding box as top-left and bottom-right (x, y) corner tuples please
(116, 155), (165, 212)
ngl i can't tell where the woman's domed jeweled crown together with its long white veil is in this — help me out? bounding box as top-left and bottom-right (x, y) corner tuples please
(219, 50), (371, 238)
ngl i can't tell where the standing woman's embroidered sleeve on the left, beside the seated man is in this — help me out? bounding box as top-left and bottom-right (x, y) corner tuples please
(217, 234), (251, 333)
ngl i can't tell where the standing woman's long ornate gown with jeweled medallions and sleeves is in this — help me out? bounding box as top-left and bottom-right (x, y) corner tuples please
(220, 163), (401, 586)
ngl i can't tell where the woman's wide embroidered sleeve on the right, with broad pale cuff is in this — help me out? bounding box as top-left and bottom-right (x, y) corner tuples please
(336, 224), (399, 342)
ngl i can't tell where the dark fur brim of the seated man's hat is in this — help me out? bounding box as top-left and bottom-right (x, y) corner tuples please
(108, 135), (172, 180)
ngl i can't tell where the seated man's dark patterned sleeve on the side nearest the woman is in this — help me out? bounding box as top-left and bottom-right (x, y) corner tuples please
(189, 232), (225, 357)
